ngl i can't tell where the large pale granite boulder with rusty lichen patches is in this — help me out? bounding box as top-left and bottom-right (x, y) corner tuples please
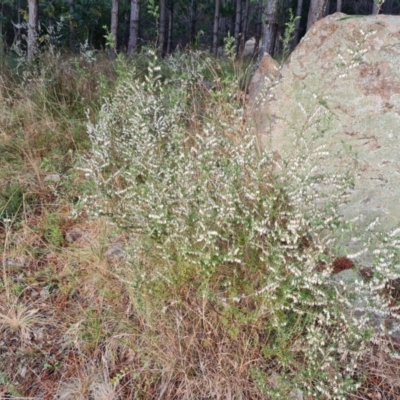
(250, 13), (400, 262)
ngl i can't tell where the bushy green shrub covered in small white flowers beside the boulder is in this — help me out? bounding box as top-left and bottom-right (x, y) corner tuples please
(82, 50), (398, 399)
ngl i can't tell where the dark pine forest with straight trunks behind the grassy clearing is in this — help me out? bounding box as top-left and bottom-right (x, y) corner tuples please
(0, 0), (400, 61)
